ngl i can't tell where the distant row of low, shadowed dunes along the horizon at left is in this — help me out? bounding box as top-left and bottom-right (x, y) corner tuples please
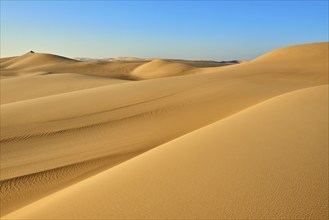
(0, 52), (233, 80)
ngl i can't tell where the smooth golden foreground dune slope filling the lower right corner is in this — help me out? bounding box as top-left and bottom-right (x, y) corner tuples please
(5, 86), (328, 219)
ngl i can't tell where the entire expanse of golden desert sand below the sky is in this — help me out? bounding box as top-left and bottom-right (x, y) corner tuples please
(0, 43), (329, 219)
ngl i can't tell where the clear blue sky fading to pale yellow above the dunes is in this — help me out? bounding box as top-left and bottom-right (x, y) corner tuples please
(1, 0), (328, 60)
